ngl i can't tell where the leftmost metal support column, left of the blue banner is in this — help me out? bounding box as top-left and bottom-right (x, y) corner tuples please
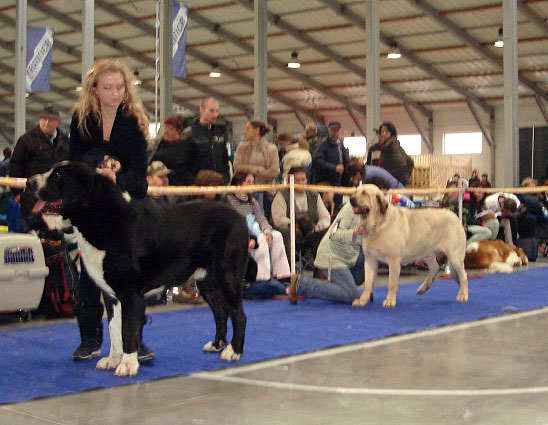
(13, 0), (27, 141)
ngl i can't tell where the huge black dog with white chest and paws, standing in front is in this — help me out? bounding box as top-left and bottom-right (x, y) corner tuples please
(27, 162), (249, 376)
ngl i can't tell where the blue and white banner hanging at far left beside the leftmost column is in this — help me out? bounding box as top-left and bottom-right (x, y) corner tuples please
(26, 27), (53, 93)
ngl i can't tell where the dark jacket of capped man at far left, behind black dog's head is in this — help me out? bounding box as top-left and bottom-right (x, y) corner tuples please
(9, 125), (68, 178)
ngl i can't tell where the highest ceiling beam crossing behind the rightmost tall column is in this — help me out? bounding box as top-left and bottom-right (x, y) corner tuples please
(407, 0), (548, 101)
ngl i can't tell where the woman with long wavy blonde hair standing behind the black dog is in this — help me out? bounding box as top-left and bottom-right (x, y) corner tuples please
(69, 59), (154, 362)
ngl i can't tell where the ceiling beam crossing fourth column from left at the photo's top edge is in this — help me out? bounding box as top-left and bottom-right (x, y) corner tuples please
(236, 0), (430, 115)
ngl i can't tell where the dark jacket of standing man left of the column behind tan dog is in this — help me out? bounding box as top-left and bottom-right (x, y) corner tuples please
(312, 136), (348, 186)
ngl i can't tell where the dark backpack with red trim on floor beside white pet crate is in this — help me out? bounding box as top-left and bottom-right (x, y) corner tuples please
(38, 240), (79, 318)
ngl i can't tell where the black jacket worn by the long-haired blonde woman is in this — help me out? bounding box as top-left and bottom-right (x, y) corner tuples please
(69, 106), (148, 198)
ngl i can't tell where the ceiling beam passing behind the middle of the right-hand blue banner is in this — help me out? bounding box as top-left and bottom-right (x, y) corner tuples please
(90, 0), (317, 122)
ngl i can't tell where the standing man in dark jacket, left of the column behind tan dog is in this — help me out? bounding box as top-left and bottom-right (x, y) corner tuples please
(312, 121), (348, 211)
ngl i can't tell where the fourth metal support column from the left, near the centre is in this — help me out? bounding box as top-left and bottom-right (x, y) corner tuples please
(253, 0), (268, 122)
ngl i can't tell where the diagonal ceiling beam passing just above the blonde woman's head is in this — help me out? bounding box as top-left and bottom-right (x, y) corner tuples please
(27, 0), (254, 115)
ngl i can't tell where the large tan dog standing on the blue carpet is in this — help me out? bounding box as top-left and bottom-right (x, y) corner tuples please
(350, 184), (468, 307)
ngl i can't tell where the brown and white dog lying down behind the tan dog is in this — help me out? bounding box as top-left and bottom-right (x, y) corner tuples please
(464, 239), (529, 273)
